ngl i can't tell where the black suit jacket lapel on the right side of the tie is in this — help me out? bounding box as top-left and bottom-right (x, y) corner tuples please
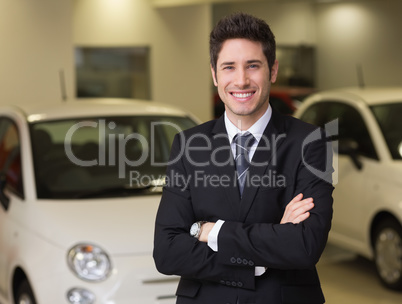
(240, 110), (286, 221)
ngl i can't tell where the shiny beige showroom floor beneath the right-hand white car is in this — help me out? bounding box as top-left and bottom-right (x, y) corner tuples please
(317, 245), (402, 304)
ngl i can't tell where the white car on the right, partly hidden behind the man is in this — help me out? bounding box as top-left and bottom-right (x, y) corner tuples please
(295, 88), (402, 290)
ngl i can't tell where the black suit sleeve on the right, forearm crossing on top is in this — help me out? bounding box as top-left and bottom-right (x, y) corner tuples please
(218, 128), (333, 269)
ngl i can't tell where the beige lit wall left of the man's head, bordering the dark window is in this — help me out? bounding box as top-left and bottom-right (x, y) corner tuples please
(73, 0), (212, 120)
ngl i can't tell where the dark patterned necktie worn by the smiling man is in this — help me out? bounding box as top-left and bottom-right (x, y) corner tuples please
(233, 132), (255, 197)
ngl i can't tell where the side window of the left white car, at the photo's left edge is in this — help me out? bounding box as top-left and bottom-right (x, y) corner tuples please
(0, 118), (24, 198)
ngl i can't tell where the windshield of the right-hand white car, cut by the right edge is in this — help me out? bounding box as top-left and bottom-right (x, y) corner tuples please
(371, 102), (402, 160)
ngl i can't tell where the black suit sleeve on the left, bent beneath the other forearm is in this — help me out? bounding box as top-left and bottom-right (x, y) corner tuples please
(153, 135), (254, 289)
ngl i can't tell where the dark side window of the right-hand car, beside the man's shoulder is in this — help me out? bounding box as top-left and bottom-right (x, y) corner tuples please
(301, 101), (378, 159)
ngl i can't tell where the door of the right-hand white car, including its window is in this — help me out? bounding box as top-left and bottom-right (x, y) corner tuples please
(301, 100), (378, 249)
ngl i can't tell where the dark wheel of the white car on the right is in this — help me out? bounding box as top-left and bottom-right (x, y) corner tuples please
(374, 219), (402, 290)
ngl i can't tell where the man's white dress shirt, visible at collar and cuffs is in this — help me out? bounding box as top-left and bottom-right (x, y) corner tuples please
(208, 105), (272, 276)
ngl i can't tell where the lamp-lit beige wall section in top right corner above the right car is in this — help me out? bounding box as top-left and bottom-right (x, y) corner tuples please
(315, 0), (402, 89)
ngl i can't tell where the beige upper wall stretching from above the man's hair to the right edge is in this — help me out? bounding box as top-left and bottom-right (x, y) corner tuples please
(217, 0), (402, 89)
